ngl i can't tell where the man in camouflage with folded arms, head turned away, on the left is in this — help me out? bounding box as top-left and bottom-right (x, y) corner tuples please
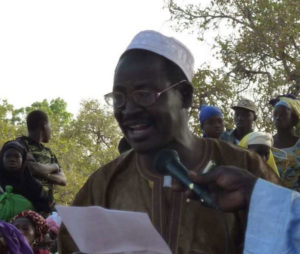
(17, 110), (66, 209)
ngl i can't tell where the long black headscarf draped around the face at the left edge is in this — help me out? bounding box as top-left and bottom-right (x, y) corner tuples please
(0, 141), (50, 212)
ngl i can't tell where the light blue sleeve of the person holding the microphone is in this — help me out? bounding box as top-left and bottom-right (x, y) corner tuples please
(243, 179), (300, 254)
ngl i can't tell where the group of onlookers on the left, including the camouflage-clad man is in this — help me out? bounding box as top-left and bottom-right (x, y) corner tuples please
(0, 110), (66, 254)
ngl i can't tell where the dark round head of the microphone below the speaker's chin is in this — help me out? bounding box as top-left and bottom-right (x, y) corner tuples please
(154, 149), (180, 174)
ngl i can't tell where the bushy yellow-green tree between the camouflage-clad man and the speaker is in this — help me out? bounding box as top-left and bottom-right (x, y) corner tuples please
(56, 100), (121, 203)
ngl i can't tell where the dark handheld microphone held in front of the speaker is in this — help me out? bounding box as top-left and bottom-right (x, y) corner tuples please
(154, 149), (217, 209)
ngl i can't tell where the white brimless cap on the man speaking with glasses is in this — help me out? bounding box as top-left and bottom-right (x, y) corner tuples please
(123, 30), (194, 81)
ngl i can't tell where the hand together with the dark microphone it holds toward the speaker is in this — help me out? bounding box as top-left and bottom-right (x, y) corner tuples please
(155, 149), (257, 212)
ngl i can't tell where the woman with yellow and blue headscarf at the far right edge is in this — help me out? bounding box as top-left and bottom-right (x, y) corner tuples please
(270, 96), (300, 191)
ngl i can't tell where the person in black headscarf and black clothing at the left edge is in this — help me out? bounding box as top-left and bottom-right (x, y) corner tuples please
(0, 141), (50, 213)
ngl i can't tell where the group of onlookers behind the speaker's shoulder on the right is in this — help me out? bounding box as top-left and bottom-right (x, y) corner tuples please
(199, 94), (300, 191)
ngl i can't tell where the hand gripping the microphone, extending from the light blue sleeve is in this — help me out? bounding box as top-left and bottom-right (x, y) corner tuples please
(189, 166), (257, 212)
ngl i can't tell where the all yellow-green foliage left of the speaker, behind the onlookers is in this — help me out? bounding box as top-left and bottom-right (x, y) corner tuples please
(0, 98), (120, 204)
